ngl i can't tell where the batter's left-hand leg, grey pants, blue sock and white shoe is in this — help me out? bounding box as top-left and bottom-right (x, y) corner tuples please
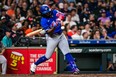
(30, 36), (58, 73)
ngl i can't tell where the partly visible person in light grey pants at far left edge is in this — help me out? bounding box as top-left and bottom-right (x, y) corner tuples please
(0, 42), (7, 74)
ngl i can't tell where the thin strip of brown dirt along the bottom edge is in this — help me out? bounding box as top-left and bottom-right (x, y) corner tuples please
(0, 74), (116, 77)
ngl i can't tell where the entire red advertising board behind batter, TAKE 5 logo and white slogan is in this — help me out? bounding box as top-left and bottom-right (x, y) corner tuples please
(4, 48), (56, 74)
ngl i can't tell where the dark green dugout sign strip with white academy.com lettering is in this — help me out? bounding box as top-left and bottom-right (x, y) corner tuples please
(70, 47), (116, 53)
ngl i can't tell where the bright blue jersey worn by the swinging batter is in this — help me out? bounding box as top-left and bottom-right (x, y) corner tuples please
(40, 10), (62, 34)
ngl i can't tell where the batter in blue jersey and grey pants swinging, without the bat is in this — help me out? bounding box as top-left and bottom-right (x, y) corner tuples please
(30, 5), (79, 74)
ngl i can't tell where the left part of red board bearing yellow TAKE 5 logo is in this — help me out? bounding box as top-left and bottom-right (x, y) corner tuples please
(5, 49), (29, 74)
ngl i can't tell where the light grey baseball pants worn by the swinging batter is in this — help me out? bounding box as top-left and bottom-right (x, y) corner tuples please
(45, 33), (70, 59)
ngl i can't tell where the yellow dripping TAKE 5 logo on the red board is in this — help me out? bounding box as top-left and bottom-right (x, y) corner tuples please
(10, 51), (24, 70)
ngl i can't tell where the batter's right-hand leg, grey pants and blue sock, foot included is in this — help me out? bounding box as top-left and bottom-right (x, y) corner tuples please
(58, 34), (79, 73)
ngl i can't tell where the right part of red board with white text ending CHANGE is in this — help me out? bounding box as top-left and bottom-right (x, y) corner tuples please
(29, 49), (57, 74)
